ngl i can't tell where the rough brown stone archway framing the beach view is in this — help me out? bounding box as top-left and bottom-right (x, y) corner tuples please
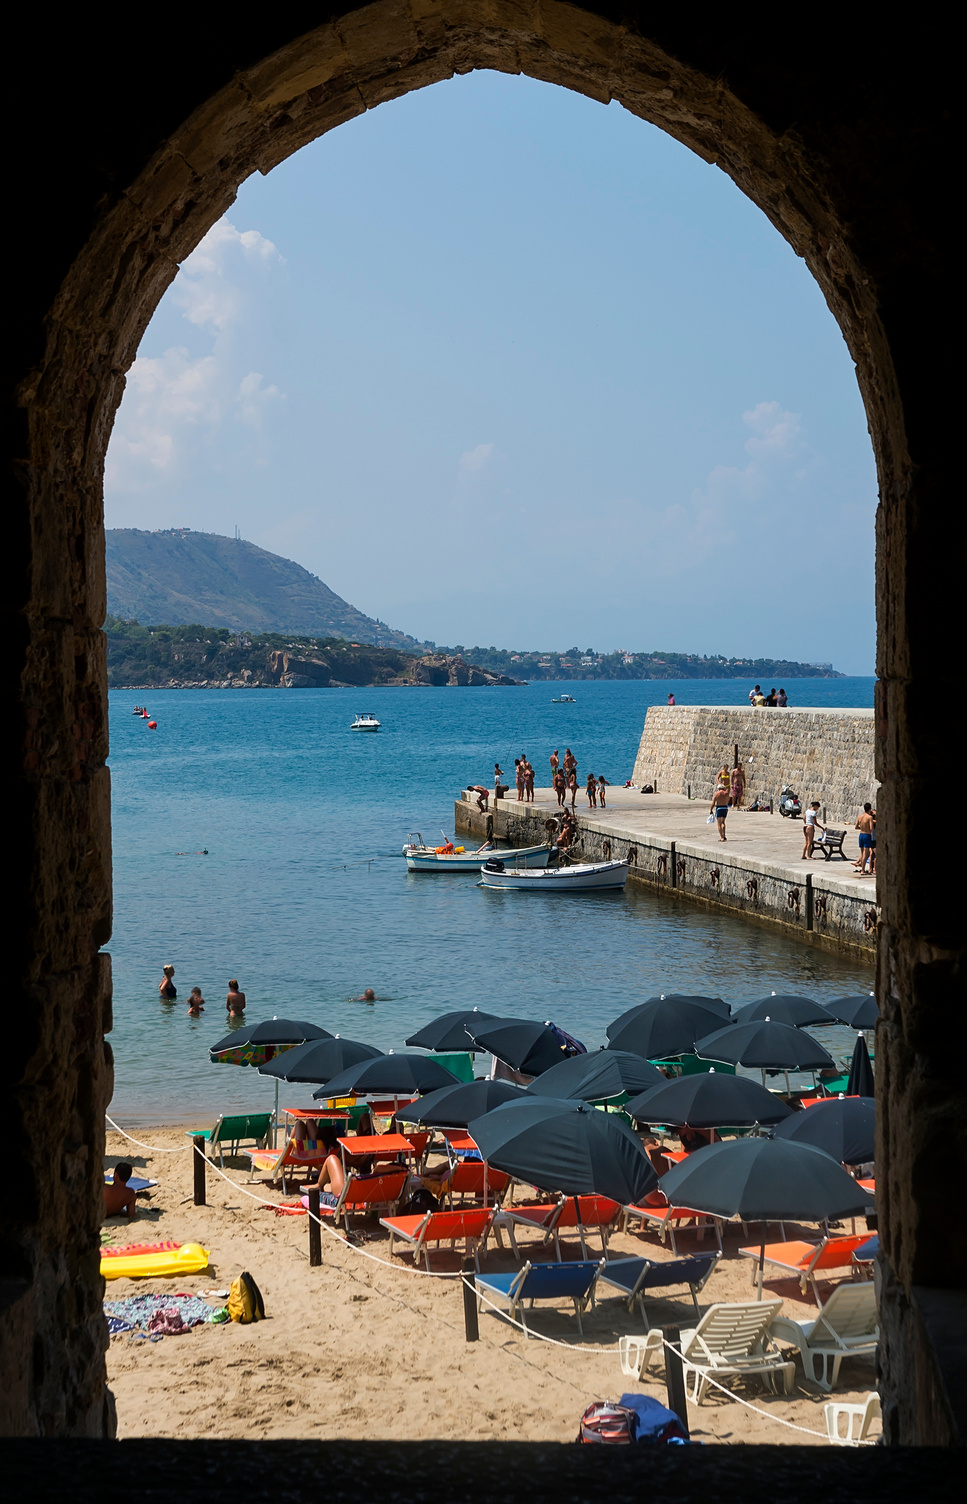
(3, 0), (964, 1441)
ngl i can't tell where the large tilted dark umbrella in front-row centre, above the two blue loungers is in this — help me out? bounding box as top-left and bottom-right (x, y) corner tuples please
(468, 1096), (659, 1205)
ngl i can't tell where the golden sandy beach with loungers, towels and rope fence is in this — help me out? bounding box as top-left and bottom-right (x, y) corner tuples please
(104, 1128), (874, 1445)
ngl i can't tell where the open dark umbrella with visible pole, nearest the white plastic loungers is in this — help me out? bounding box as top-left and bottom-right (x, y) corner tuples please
(662, 1139), (869, 1299)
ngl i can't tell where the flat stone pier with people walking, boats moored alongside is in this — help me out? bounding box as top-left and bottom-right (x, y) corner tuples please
(454, 787), (880, 961)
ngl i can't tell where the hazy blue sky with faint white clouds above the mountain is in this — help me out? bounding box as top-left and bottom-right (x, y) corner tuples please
(105, 72), (877, 674)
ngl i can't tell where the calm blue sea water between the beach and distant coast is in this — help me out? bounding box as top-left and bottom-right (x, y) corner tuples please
(108, 678), (874, 1125)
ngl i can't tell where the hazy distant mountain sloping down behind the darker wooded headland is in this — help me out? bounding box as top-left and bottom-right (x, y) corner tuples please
(105, 528), (432, 650)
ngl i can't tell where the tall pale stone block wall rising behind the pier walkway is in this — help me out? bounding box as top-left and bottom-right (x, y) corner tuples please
(633, 705), (877, 824)
